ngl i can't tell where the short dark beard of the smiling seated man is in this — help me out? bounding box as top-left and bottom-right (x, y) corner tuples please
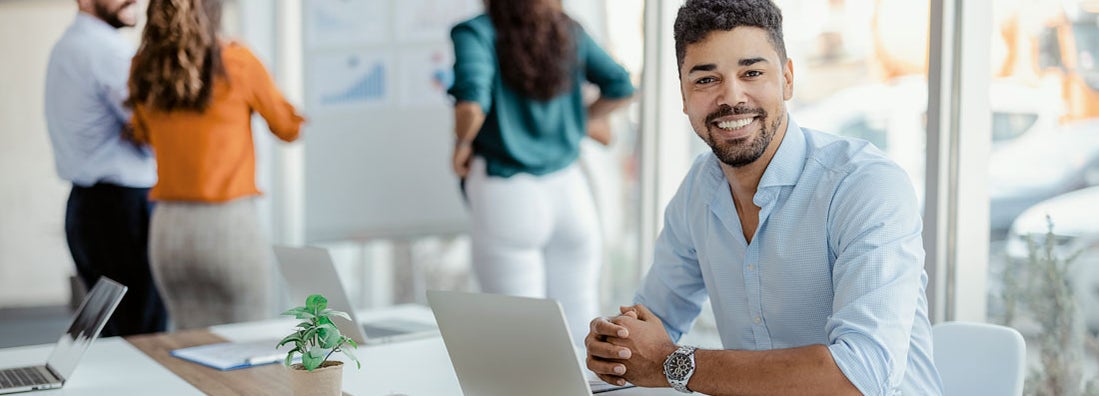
(703, 105), (780, 167)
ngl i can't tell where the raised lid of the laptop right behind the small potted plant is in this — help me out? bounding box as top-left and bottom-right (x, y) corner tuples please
(273, 245), (367, 344)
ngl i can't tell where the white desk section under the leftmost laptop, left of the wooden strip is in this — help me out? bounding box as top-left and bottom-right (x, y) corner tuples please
(0, 337), (195, 396)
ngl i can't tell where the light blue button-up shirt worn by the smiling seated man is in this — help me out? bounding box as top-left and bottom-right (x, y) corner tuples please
(635, 117), (942, 395)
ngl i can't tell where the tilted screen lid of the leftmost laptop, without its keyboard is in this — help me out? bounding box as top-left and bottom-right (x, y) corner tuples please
(46, 276), (126, 381)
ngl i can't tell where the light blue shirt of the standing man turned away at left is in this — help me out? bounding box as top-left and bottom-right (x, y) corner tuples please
(45, 12), (156, 187)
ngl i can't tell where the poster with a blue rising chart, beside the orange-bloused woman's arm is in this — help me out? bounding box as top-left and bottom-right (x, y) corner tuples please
(307, 51), (392, 113)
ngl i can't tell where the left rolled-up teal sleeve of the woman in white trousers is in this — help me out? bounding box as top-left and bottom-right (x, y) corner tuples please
(447, 23), (496, 112)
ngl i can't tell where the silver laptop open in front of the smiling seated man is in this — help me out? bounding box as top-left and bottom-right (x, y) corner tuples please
(428, 290), (632, 396)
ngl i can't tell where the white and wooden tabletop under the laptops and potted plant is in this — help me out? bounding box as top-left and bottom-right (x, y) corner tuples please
(0, 307), (679, 396)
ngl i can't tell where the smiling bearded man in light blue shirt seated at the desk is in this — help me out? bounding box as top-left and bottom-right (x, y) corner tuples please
(585, 0), (942, 395)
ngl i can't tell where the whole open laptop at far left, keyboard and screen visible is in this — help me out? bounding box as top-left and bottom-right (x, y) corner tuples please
(0, 276), (126, 394)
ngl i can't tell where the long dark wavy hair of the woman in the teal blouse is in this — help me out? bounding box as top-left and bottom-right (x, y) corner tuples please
(486, 0), (576, 100)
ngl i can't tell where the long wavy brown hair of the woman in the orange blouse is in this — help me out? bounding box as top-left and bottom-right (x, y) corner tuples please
(126, 0), (225, 111)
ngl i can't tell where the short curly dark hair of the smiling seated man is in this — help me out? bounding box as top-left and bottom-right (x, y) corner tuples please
(674, 0), (786, 67)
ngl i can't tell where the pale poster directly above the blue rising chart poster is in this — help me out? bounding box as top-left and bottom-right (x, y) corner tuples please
(302, 0), (391, 50)
